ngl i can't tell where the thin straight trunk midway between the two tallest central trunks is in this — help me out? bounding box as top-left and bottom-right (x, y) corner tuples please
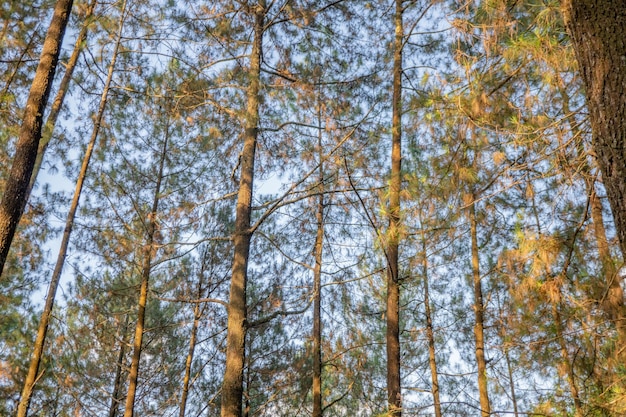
(312, 96), (324, 417)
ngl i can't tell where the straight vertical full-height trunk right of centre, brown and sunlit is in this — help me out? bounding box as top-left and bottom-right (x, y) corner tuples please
(386, 0), (404, 417)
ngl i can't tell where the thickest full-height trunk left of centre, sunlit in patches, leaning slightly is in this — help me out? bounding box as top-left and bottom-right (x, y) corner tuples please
(221, 0), (266, 417)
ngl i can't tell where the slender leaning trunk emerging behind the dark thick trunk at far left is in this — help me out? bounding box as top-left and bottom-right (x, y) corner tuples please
(26, 0), (98, 199)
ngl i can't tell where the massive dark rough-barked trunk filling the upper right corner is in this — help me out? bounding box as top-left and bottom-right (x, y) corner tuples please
(562, 0), (626, 259)
